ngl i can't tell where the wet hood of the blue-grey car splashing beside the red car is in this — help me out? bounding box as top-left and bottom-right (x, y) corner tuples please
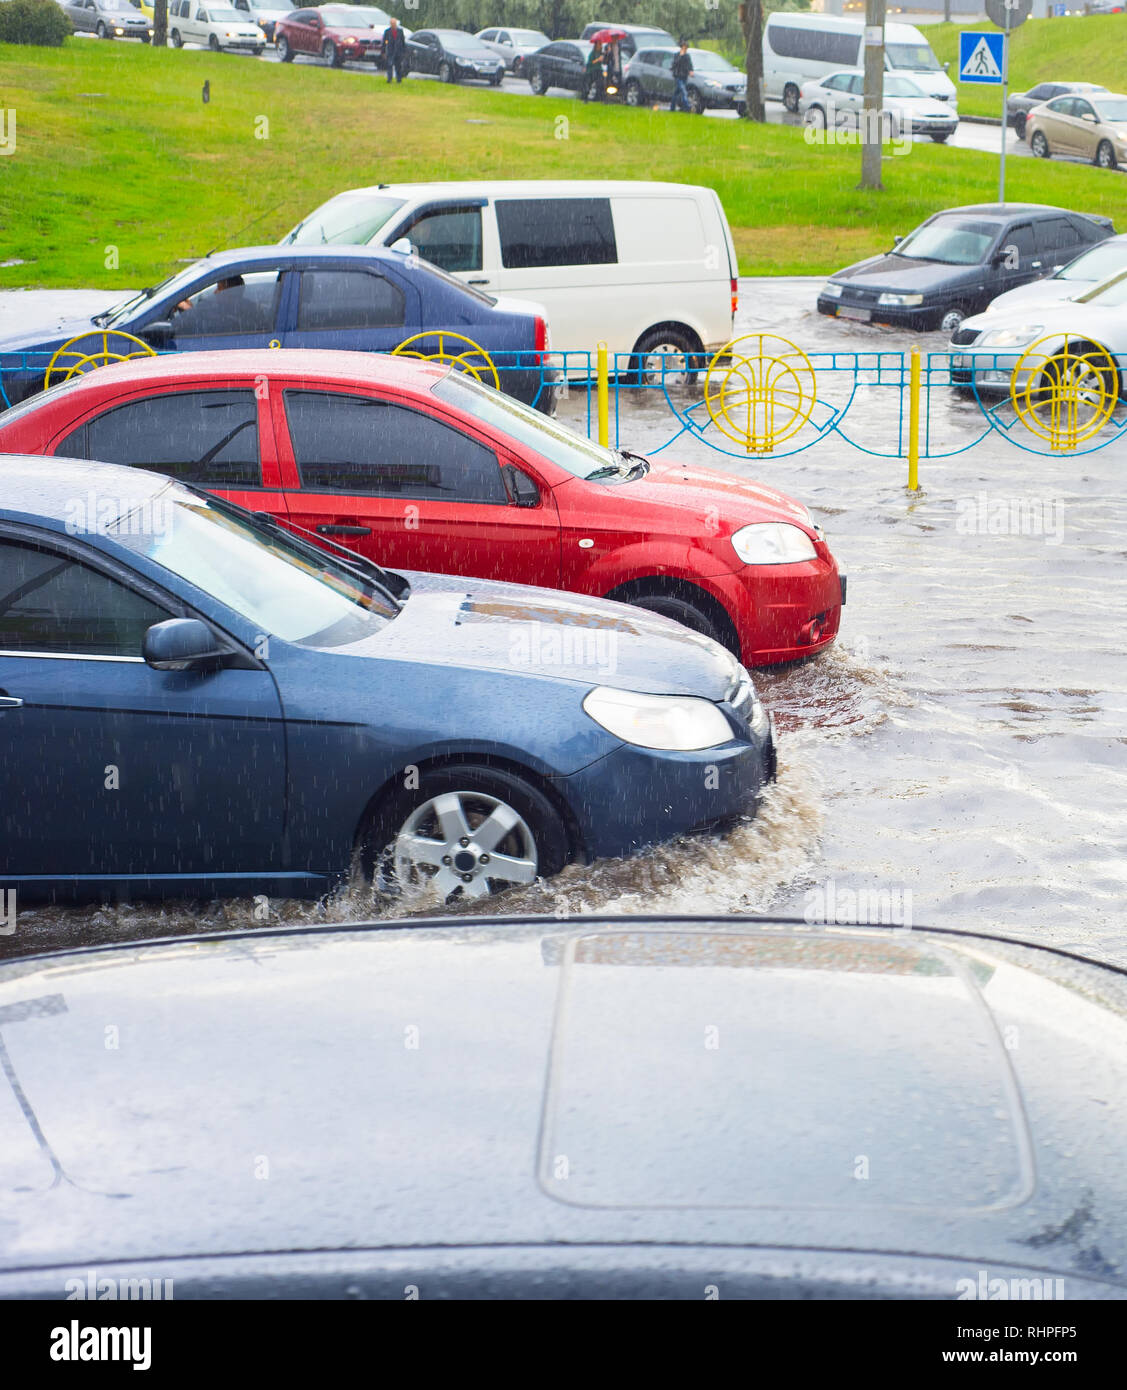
(329, 571), (739, 701)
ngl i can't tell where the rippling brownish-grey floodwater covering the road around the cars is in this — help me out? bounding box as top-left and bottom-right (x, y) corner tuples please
(0, 279), (1127, 962)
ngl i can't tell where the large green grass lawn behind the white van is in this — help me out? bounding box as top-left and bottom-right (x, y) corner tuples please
(0, 38), (1127, 289)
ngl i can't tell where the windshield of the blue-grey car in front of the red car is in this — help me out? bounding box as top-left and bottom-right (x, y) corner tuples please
(106, 482), (399, 646)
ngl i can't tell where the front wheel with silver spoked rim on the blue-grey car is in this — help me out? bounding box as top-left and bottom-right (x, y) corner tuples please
(359, 760), (573, 901)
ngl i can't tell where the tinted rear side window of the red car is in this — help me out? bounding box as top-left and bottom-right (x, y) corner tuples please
(54, 391), (263, 488)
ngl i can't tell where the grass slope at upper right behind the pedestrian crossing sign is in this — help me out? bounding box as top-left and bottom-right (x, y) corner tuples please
(923, 14), (1127, 117)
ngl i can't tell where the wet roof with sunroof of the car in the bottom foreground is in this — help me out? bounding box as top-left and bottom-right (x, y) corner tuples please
(0, 906), (1127, 1289)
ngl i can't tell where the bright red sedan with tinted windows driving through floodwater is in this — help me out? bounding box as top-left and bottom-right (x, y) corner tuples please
(0, 349), (845, 666)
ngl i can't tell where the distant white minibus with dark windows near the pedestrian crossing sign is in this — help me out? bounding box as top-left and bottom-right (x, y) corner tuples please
(763, 13), (956, 111)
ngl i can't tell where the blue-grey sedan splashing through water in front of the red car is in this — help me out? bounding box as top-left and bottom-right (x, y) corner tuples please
(0, 457), (774, 902)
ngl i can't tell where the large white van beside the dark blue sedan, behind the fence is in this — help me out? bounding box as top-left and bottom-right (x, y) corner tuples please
(283, 179), (739, 371)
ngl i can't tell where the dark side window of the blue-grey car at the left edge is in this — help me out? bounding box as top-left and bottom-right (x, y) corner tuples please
(0, 536), (174, 657)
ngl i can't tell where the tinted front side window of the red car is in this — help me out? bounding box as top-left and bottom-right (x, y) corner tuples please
(285, 389), (509, 506)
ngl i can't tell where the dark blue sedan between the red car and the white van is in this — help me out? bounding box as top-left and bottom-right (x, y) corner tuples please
(0, 246), (559, 413)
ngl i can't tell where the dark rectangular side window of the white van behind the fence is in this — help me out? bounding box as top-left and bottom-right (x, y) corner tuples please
(496, 197), (618, 270)
